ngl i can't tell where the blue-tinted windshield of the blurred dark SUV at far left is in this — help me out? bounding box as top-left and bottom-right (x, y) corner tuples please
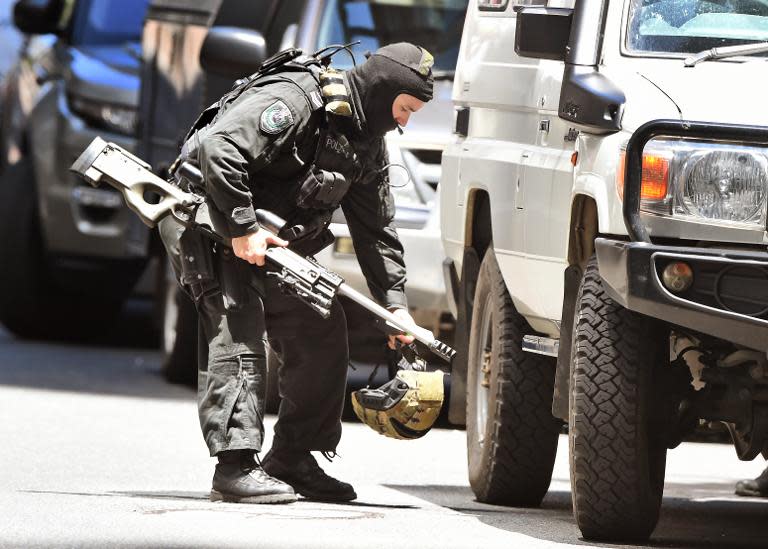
(72, 0), (149, 45)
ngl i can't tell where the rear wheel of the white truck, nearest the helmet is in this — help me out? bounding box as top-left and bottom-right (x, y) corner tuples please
(467, 247), (560, 507)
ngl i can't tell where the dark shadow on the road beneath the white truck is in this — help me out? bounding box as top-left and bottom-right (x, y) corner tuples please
(388, 482), (768, 549)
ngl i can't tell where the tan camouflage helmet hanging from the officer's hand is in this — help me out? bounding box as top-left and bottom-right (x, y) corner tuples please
(352, 370), (444, 440)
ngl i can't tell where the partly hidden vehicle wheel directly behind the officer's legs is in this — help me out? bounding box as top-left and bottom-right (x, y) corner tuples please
(159, 259), (197, 387)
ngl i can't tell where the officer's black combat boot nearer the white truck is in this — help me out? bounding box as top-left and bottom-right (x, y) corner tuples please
(262, 449), (357, 501)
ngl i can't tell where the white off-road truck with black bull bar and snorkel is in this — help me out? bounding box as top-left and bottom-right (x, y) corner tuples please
(440, 0), (768, 540)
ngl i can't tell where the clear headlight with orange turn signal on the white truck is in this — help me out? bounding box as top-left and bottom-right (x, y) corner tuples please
(616, 139), (768, 231)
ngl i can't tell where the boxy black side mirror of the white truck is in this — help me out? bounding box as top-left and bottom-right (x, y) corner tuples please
(515, 6), (573, 61)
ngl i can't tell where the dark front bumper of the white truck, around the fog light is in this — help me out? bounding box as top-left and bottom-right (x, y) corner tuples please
(595, 238), (768, 352)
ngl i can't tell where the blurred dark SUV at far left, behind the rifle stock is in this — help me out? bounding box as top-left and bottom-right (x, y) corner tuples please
(0, 0), (150, 337)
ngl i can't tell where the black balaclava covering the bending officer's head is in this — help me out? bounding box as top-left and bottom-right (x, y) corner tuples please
(347, 42), (434, 137)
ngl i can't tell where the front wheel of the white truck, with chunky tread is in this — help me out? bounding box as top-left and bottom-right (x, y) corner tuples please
(569, 257), (669, 541)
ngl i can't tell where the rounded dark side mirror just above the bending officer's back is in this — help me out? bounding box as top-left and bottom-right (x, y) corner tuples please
(200, 27), (267, 79)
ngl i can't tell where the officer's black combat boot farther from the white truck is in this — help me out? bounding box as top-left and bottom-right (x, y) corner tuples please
(211, 450), (297, 503)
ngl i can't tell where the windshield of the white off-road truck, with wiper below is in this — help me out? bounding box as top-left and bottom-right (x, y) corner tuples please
(627, 0), (768, 54)
